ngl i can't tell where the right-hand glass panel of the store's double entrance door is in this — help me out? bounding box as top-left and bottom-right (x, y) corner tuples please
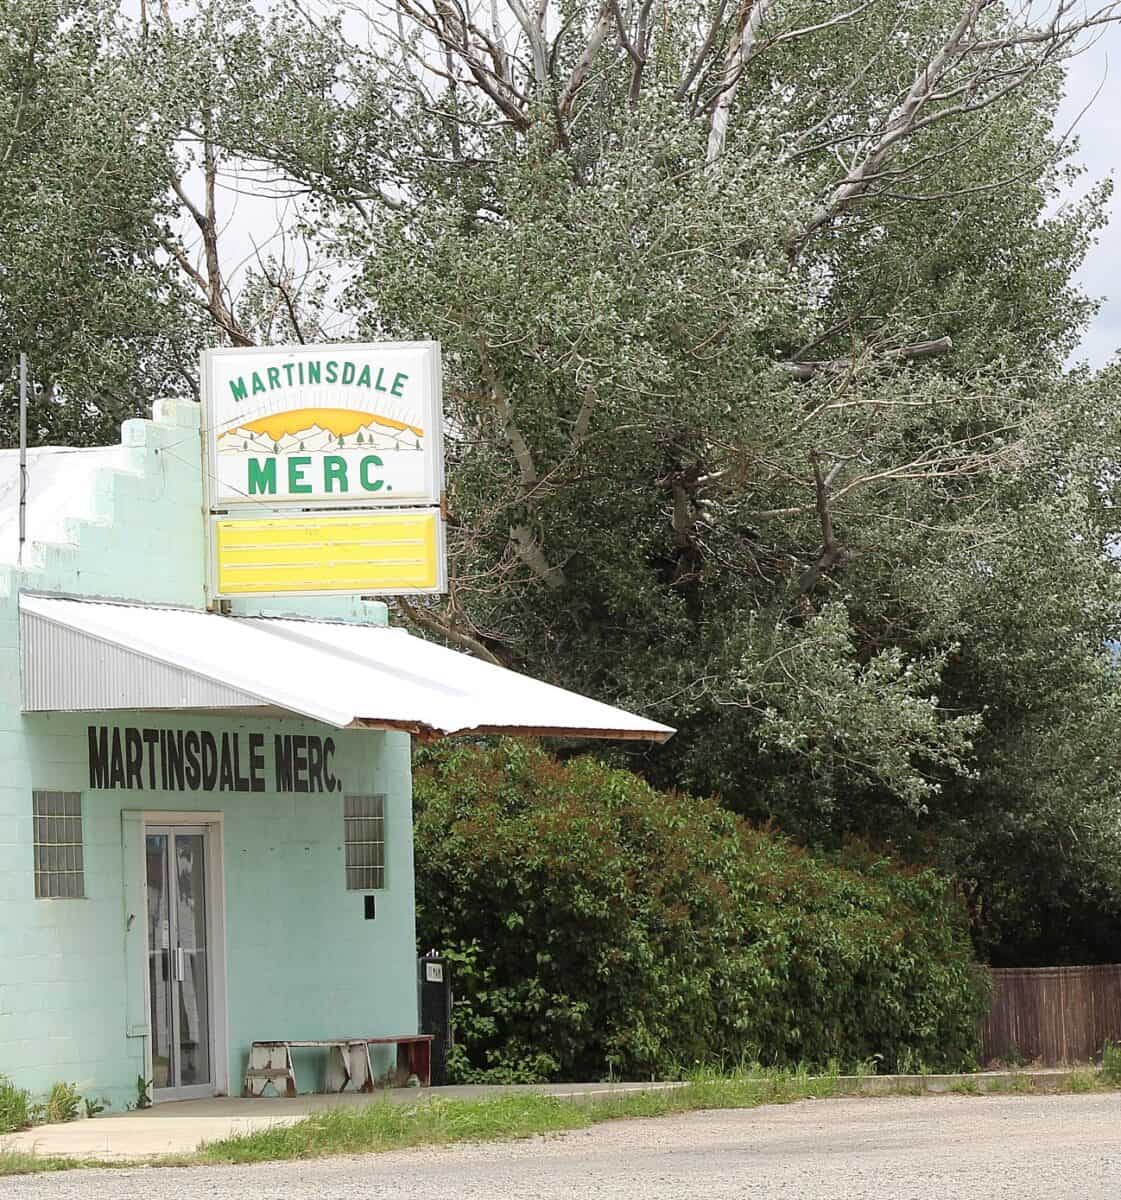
(175, 833), (210, 1086)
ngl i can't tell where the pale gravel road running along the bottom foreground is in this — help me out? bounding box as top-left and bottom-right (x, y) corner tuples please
(0, 1093), (1121, 1200)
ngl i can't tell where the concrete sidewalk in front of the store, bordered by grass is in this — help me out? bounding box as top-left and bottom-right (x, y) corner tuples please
(0, 1084), (681, 1162)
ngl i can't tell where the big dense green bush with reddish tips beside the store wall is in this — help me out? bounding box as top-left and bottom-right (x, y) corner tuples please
(415, 742), (985, 1082)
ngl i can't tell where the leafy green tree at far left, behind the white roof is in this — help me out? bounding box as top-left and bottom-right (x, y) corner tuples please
(0, 0), (203, 445)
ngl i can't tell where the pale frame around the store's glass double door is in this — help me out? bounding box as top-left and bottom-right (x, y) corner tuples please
(139, 809), (229, 1104)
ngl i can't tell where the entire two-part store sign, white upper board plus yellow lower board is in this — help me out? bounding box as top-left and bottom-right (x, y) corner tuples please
(203, 342), (446, 598)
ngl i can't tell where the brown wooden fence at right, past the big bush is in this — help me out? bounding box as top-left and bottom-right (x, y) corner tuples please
(982, 965), (1121, 1067)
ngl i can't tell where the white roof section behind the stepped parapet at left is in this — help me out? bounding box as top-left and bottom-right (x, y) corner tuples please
(0, 446), (121, 564)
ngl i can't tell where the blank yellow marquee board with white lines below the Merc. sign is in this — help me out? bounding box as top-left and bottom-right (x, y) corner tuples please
(210, 509), (446, 596)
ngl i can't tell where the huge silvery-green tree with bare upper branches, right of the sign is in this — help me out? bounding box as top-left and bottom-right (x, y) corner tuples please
(8, 0), (1121, 958)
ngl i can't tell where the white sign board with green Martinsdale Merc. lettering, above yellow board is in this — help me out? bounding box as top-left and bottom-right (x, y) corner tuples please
(203, 342), (443, 511)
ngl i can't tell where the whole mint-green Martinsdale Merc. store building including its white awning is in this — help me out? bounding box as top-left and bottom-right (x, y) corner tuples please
(0, 402), (671, 1109)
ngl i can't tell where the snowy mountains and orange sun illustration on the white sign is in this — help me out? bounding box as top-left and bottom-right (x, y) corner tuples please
(218, 408), (424, 455)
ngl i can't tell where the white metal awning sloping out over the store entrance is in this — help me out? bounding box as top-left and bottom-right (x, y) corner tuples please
(19, 594), (673, 742)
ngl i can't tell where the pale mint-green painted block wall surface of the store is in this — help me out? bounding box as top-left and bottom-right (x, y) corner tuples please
(0, 403), (416, 1108)
